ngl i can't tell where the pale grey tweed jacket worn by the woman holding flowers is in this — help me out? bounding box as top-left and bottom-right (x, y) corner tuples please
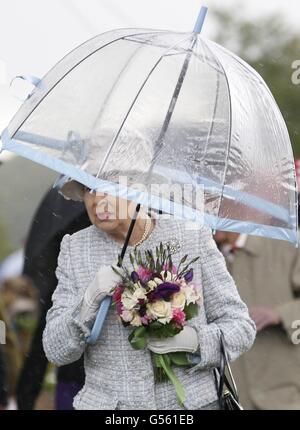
(43, 217), (256, 409)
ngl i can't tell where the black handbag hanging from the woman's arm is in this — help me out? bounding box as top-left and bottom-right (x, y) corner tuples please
(214, 333), (243, 410)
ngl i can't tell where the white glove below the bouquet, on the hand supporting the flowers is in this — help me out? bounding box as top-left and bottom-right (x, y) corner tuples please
(147, 326), (198, 354)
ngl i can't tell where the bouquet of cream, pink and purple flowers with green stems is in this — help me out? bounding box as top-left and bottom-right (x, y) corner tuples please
(113, 243), (201, 404)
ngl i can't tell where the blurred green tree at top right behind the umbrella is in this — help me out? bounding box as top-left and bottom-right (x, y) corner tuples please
(212, 7), (300, 157)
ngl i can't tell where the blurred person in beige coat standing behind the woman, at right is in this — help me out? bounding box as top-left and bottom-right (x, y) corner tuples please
(215, 231), (300, 410)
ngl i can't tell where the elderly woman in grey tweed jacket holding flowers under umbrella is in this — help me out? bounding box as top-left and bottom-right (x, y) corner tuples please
(43, 184), (255, 409)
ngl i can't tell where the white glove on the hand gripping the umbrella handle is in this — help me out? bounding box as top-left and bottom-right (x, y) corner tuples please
(80, 266), (121, 321)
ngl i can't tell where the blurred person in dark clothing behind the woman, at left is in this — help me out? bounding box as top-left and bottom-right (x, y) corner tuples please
(17, 188), (90, 410)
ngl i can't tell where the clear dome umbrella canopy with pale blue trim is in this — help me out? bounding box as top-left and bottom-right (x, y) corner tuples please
(2, 29), (297, 244)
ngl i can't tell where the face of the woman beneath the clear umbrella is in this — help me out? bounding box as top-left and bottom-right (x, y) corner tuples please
(83, 188), (131, 232)
